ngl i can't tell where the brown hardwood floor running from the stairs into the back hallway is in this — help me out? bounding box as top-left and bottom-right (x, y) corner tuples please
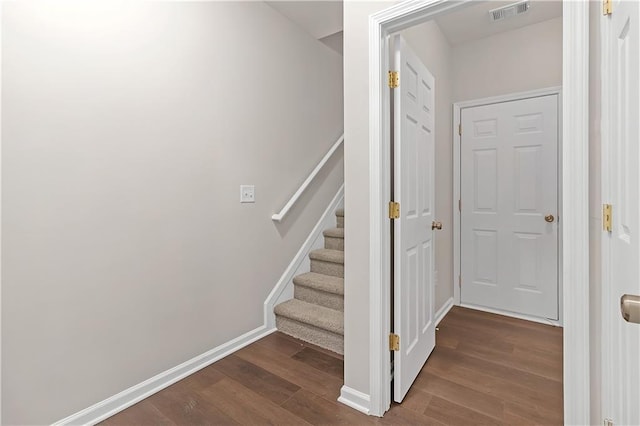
(102, 307), (563, 426)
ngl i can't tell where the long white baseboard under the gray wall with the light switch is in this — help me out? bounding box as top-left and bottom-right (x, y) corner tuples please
(53, 325), (275, 426)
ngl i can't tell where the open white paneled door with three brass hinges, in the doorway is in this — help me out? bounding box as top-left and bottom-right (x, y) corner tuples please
(393, 36), (435, 402)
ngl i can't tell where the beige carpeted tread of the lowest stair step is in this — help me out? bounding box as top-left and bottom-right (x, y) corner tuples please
(274, 299), (344, 336)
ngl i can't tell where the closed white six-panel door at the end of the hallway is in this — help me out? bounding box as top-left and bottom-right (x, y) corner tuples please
(460, 94), (558, 320)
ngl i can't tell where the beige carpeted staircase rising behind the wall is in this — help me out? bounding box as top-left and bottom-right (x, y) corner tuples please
(274, 209), (344, 354)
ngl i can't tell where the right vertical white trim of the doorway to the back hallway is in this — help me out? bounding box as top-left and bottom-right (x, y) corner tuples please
(562, 2), (591, 424)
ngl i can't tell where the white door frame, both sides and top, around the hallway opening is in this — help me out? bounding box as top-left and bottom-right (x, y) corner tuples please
(368, 0), (591, 424)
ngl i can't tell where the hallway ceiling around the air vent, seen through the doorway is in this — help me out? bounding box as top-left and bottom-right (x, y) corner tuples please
(435, 0), (562, 46)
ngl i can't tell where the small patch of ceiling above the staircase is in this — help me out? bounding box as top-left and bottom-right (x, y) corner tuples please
(265, 0), (342, 39)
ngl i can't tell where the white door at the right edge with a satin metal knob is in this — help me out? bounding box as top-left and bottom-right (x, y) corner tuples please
(594, 1), (640, 425)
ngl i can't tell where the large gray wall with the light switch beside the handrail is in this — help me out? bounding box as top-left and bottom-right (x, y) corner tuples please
(2, 1), (344, 424)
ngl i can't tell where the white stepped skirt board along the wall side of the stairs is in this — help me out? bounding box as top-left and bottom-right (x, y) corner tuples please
(264, 184), (344, 328)
